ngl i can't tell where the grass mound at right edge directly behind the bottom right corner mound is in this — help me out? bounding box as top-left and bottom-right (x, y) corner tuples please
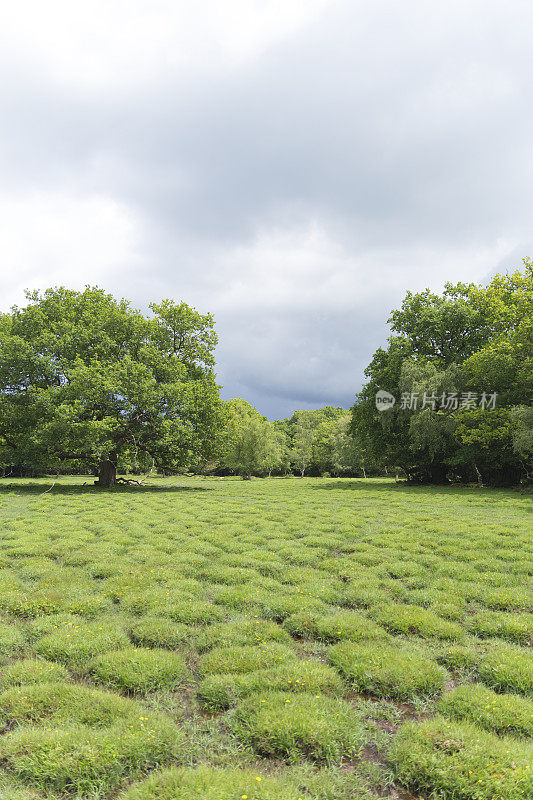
(438, 684), (533, 736)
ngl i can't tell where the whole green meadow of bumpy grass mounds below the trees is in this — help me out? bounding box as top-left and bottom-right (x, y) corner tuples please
(0, 476), (533, 800)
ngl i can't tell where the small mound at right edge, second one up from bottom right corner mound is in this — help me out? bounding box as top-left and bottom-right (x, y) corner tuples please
(476, 642), (533, 695)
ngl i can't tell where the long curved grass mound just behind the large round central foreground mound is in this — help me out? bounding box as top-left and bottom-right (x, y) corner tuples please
(198, 661), (343, 711)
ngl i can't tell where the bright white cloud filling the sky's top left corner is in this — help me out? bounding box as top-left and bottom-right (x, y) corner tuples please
(1, 0), (331, 94)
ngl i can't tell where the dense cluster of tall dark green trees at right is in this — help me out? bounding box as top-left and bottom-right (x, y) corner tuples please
(351, 259), (533, 485)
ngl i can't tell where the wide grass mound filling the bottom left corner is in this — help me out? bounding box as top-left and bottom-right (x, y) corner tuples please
(0, 715), (186, 798)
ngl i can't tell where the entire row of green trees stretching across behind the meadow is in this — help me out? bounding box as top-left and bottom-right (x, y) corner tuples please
(0, 259), (533, 487)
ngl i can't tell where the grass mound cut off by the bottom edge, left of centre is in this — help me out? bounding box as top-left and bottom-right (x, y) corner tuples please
(120, 766), (310, 800)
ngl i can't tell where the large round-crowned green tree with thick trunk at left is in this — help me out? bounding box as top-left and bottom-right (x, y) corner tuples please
(0, 288), (218, 485)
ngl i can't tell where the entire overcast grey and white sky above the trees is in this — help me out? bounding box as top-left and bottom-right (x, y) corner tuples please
(0, 0), (533, 417)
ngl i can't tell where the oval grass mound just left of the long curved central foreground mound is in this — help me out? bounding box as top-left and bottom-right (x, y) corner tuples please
(88, 647), (187, 692)
